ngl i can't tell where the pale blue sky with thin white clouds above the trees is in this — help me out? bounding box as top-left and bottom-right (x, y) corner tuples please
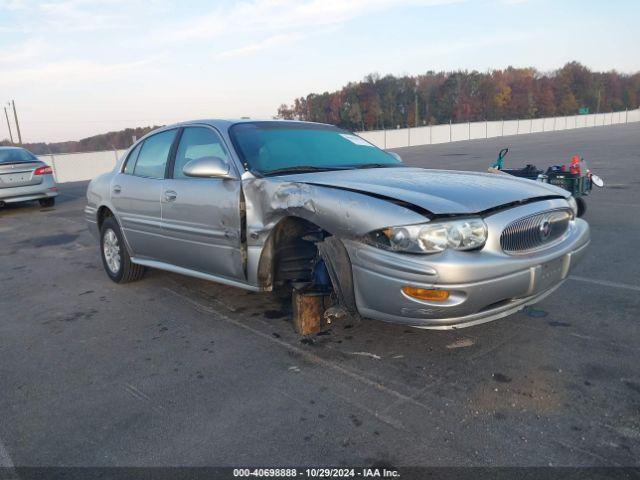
(0, 0), (640, 141)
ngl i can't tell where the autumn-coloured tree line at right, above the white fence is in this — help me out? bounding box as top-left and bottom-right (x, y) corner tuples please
(278, 62), (640, 130)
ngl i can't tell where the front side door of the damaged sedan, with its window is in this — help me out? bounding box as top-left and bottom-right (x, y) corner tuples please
(161, 126), (245, 280)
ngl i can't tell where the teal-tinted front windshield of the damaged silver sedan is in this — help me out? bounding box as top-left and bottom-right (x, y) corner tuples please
(229, 122), (401, 175)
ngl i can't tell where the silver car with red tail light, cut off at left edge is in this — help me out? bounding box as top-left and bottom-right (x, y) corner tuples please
(0, 147), (58, 207)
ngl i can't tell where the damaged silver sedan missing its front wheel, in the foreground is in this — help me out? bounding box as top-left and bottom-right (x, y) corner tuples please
(85, 120), (589, 329)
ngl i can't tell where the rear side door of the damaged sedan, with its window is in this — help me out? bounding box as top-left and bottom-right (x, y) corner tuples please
(111, 129), (177, 260)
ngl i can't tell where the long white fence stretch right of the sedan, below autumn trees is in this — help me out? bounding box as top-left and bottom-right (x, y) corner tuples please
(358, 109), (640, 149)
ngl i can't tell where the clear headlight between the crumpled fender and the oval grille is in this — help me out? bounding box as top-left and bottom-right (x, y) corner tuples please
(370, 218), (487, 253)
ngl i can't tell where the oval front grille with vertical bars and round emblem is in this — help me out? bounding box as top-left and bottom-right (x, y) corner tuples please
(500, 209), (573, 254)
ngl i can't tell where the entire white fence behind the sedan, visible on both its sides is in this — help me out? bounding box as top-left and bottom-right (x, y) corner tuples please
(39, 109), (640, 183)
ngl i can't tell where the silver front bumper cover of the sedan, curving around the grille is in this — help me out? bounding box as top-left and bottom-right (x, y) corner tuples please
(345, 200), (589, 329)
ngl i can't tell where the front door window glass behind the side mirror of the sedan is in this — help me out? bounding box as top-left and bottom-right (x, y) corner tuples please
(173, 127), (229, 178)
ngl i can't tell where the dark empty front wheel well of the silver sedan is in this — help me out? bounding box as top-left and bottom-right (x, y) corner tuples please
(258, 217), (329, 290)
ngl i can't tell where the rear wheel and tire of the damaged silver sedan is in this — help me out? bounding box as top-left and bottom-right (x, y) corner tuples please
(100, 217), (144, 283)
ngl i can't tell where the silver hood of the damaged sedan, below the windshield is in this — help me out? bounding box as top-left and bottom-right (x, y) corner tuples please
(272, 167), (569, 214)
